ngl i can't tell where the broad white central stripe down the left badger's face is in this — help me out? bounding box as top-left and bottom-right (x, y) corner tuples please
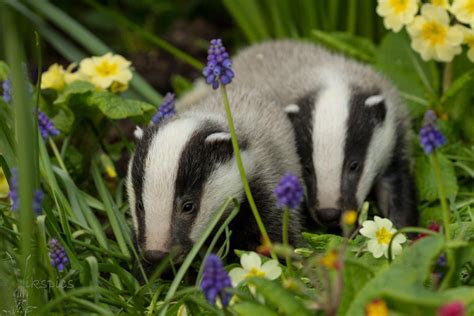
(143, 118), (199, 251)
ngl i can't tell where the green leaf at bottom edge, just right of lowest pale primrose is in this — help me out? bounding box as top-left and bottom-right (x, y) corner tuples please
(249, 277), (312, 316)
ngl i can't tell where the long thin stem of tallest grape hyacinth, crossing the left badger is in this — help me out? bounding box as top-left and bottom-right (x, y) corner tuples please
(221, 85), (273, 249)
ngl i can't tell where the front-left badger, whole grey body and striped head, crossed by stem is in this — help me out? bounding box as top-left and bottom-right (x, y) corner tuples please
(127, 89), (301, 261)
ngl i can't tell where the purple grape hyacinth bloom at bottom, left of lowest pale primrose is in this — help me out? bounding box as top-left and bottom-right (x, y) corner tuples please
(201, 254), (232, 306)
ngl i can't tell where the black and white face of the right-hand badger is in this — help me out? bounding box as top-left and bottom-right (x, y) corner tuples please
(286, 75), (396, 227)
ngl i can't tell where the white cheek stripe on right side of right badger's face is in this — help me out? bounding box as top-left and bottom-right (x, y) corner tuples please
(356, 100), (396, 207)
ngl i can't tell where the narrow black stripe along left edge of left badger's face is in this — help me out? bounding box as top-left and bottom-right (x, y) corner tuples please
(131, 125), (161, 245)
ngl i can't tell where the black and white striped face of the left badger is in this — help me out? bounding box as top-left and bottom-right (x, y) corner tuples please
(127, 117), (252, 262)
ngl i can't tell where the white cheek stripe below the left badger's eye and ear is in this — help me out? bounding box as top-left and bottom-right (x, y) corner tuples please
(189, 151), (255, 242)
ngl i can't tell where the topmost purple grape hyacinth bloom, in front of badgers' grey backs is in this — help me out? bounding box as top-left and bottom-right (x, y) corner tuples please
(202, 39), (234, 90)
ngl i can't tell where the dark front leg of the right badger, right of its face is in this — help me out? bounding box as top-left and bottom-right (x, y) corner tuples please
(375, 157), (418, 228)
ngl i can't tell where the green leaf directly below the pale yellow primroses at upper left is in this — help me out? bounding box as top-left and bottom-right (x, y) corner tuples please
(86, 92), (156, 120)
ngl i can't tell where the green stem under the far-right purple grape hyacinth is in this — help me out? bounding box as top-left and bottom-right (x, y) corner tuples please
(430, 152), (456, 289)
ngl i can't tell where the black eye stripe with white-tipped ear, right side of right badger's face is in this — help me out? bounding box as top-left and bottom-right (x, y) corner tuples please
(339, 88), (387, 210)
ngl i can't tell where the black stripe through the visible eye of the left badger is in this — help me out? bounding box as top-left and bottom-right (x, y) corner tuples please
(170, 123), (239, 253)
